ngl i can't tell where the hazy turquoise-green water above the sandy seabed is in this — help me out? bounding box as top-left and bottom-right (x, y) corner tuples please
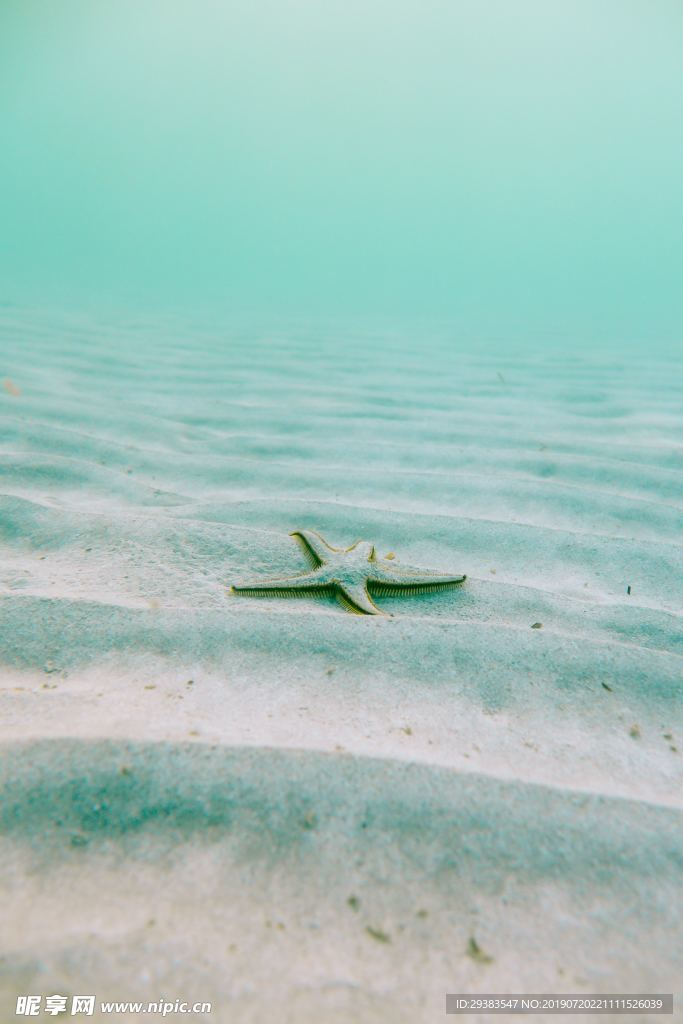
(0, 0), (683, 343)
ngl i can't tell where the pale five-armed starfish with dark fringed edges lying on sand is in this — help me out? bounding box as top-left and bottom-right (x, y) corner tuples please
(230, 529), (467, 615)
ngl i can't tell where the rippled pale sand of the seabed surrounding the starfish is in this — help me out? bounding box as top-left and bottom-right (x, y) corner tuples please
(0, 308), (683, 1024)
